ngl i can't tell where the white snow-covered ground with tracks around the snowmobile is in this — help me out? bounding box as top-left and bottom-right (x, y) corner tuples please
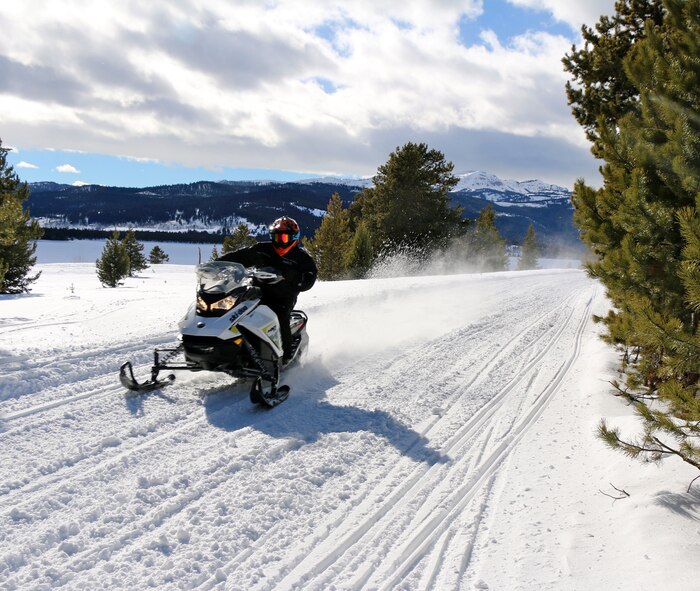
(0, 260), (700, 591)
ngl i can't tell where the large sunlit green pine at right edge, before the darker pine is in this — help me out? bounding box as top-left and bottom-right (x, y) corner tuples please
(572, 0), (700, 468)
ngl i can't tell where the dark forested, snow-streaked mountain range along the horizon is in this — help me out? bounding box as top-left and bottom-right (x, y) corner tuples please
(28, 172), (580, 254)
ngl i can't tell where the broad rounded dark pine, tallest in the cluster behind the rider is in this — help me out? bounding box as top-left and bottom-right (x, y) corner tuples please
(353, 142), (462, 252)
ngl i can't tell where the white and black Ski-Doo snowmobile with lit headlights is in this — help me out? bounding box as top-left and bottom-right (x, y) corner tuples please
(119, 261), (309, 407)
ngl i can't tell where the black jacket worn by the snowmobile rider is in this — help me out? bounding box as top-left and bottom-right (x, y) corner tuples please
(219, 242), (318, 302)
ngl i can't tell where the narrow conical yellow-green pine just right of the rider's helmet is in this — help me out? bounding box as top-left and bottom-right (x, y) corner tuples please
(304, 193), (352, 281)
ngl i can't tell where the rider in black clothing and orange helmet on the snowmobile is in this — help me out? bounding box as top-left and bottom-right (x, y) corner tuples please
(219, 216), (318, 363)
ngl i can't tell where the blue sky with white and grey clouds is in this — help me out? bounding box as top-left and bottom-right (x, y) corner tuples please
(0, 0), (614, 187)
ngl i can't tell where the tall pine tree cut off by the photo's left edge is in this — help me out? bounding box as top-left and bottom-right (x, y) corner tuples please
(0, 140), (42, 293)
